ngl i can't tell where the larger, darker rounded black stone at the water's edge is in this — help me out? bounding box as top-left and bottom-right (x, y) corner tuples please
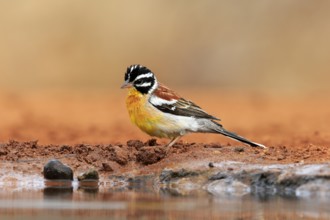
(43, 160), (73, 180)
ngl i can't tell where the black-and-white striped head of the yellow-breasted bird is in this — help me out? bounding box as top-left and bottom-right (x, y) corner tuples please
(121, 65), (158, 94)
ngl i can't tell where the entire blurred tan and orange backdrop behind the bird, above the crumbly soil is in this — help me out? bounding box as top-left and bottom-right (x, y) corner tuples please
(0, 0), (330, 145)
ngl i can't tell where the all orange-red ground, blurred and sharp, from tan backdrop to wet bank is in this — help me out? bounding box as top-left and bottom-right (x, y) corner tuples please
(0, 89), (330, 174)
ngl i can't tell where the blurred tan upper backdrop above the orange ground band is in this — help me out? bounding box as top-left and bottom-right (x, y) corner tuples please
(0, 0), (330, 92)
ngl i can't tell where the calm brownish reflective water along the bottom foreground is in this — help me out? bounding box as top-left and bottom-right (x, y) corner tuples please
(0, 182), (330, 220)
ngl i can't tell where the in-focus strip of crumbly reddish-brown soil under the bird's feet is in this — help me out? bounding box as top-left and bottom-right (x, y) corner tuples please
(0, 139), (330, 174)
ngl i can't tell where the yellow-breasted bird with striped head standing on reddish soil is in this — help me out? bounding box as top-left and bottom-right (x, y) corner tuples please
(121, 64), (266, 152)
